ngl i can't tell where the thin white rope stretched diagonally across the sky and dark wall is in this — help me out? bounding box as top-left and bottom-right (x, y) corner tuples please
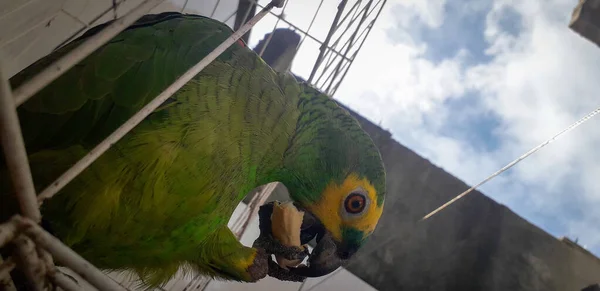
(421, 107), (600, 220)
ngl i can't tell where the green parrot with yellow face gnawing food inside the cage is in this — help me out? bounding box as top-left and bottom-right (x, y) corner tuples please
(0, 12), (385, 287)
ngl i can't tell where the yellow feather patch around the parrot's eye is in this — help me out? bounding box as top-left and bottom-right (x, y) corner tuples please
(307, 173), (383, 241)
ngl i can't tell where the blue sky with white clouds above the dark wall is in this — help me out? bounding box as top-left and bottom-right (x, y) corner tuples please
(191, 0), (600, 255)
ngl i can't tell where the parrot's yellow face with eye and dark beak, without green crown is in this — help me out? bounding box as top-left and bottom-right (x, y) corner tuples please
(292, 173), (383, 277)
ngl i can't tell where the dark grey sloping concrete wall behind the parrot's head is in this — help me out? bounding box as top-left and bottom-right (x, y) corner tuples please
(338, 105), (600, 291)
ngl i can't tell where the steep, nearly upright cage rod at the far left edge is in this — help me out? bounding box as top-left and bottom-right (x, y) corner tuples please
(0, 65), (42, 222)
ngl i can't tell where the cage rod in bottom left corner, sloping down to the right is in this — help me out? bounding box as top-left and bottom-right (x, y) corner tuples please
(13, 216), (125, 291)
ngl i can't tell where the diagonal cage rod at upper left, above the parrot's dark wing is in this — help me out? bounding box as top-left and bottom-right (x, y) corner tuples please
(14, 0), (164, 106)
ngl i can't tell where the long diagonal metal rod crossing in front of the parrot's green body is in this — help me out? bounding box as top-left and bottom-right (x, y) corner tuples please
(38, 1), (284, 204)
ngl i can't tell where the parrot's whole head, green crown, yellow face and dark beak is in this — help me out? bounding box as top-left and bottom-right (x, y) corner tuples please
(266, 86), (386, 277)
